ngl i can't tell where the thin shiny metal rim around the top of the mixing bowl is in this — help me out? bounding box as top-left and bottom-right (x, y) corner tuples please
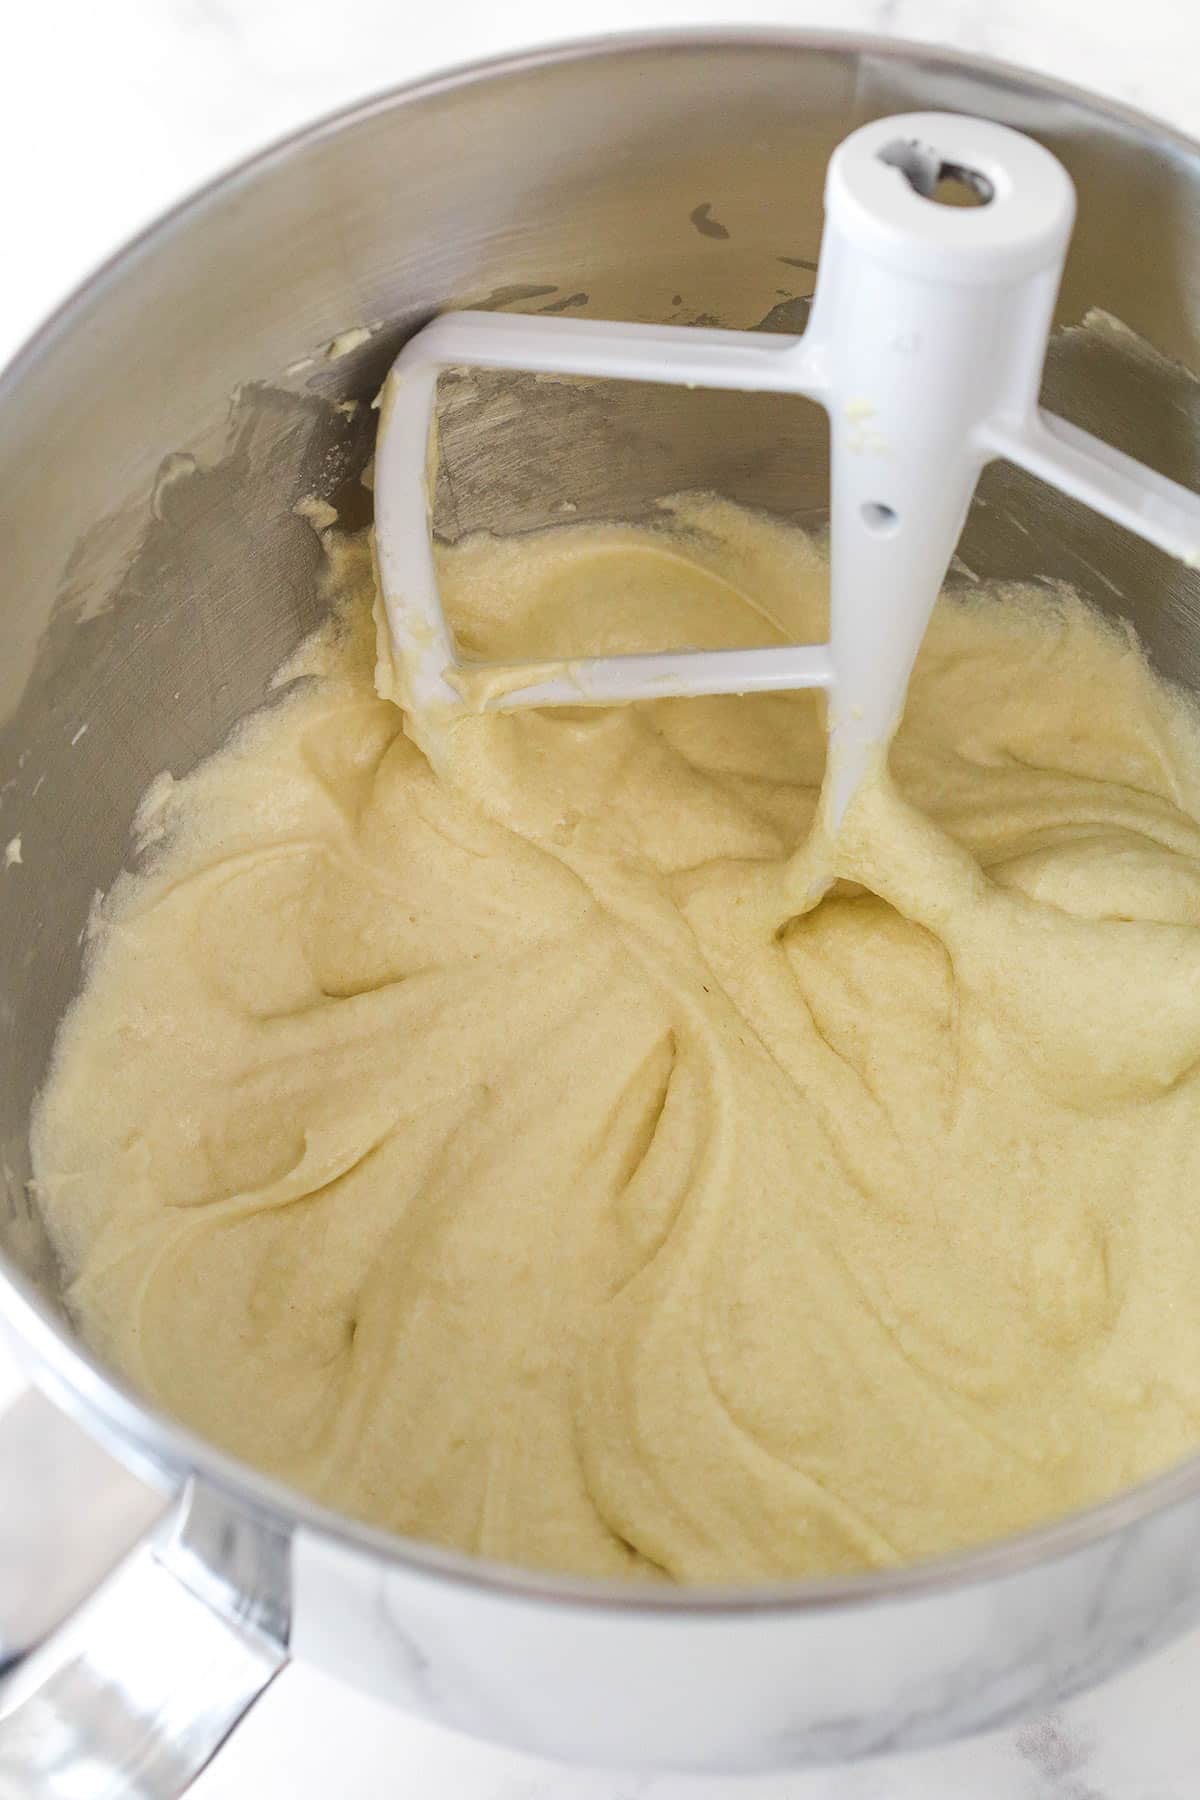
(0, 25), (1200, 1618)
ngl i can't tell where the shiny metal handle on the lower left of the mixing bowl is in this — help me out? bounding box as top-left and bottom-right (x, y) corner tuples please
(0, 1393), (290, 1800)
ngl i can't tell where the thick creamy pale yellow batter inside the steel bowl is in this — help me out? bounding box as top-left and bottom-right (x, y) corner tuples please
(34, 500), (1200, 1580)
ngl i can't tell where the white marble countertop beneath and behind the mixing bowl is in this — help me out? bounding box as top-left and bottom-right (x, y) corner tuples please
(0, 0), (1200, 1800)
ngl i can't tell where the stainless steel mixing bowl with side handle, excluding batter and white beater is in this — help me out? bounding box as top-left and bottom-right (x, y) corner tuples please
(0, 32), (1200, 1796)
